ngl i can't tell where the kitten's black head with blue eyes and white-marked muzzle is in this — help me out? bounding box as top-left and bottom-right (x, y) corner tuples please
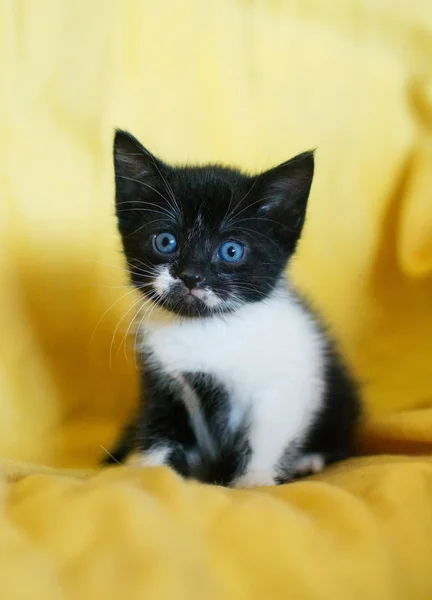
(114, 131), (314, 317)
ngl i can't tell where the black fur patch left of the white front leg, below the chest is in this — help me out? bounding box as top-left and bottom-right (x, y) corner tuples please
(105, 362), (250, 485)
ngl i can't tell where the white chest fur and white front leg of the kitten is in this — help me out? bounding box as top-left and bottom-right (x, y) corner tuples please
(140, 290), (325, 485)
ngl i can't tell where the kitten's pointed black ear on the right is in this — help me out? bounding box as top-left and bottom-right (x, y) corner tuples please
(259, 150), (314, 236)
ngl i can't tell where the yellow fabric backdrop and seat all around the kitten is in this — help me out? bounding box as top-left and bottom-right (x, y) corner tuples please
(0, 0), (432, 600)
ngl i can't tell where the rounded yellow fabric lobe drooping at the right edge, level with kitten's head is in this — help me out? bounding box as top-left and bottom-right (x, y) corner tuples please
(397, 135), (432, 277)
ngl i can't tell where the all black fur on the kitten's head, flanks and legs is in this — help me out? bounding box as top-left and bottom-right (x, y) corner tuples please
(106, 131), (359, 485)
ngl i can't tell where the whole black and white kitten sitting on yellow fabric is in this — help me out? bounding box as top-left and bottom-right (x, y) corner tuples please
(108, 131), (359, 487)
